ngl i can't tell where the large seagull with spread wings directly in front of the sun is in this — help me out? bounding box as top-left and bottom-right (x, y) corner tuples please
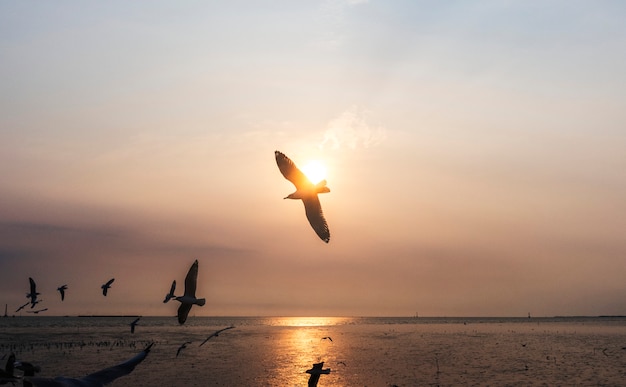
(274, 151), (330, 243)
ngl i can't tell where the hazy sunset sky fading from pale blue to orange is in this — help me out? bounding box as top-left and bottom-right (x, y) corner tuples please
(0, 0), (626, 316)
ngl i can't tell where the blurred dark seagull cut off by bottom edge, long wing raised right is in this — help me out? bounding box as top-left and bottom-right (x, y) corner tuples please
(30, 343), (154, 387)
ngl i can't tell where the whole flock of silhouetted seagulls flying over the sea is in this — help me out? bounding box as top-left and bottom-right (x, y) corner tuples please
(0, 151), (332, 386)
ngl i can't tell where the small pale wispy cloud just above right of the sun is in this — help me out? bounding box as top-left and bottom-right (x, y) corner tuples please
(319, 106), (387, 150)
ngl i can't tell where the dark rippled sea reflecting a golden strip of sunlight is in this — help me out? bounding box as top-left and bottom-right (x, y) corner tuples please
(0, 315), (626, 387)
